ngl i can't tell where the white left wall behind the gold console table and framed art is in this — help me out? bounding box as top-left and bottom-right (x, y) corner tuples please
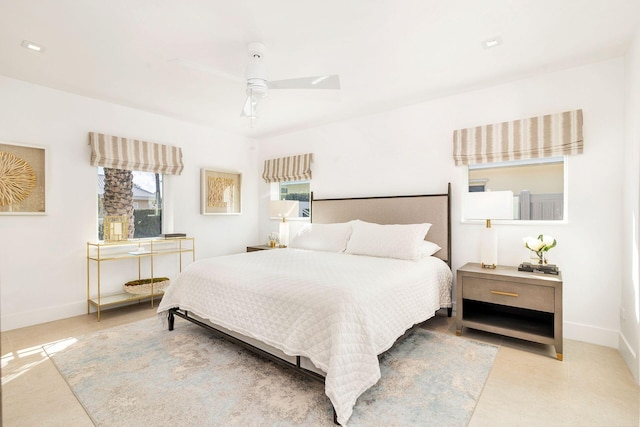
(0, 77), (259, 330)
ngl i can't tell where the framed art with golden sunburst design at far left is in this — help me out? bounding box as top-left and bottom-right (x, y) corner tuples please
(0, 141), (47, 215)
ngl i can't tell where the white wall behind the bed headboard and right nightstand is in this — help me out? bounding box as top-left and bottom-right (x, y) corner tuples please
(260, 59), (624, 347)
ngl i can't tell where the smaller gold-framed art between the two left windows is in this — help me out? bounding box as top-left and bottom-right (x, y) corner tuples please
(200, 168), (242, 215)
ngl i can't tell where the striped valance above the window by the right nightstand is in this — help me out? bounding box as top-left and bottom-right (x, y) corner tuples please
(453, 110), (583, 165)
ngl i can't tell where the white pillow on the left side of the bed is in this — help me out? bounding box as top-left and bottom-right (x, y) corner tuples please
(289, 222), (351, 252)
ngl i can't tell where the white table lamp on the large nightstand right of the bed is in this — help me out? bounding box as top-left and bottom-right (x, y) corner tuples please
(464, 191), (513, 268)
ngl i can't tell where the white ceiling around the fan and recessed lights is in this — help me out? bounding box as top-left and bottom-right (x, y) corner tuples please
(0, 0), (640, 138)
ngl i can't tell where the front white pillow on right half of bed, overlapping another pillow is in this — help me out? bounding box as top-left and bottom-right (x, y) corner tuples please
(345, 220), (431, 260)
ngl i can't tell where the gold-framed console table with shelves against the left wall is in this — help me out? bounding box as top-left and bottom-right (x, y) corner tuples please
(87, 237), (196, 321)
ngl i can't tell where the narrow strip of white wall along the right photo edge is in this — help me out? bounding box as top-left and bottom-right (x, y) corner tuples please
(619, 30), (640, 382)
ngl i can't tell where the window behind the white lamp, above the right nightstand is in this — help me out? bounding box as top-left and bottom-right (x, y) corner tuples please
(468, 157), (566, 221)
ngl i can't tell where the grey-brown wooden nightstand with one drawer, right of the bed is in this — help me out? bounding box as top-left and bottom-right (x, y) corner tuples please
(456, 263), (562, 360)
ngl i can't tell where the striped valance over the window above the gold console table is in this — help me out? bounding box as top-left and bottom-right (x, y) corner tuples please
(89, 132), (184, 175)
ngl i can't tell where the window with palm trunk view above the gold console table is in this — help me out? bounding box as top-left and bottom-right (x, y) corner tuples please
(98, 167), (163, 240)
